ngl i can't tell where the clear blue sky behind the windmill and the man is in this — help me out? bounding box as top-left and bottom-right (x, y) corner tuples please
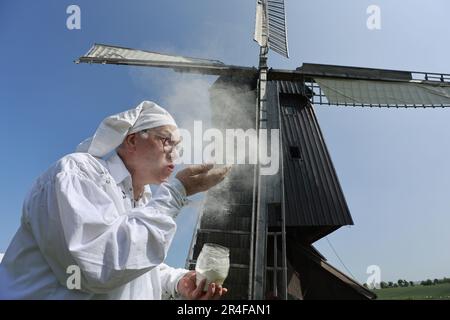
(0, 0), (450, 281)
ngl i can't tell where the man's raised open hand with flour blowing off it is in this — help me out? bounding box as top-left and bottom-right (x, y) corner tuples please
(176, 164), (230, 196)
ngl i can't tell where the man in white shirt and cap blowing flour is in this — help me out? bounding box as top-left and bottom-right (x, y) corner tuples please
(0, 101), (227, 299)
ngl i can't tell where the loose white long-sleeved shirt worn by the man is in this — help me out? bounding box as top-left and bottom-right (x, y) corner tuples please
(0, 153), (187, 299)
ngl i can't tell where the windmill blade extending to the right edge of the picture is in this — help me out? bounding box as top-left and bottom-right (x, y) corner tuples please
(272, 64), (450, 108)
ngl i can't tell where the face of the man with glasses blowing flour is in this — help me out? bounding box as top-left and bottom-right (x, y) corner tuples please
(136, 126), (180, 184)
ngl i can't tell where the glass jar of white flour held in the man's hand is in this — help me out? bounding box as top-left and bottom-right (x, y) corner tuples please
(195, 243), (230, 291)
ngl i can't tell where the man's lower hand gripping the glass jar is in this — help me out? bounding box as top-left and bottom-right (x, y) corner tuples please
(178, 271), (228, 300)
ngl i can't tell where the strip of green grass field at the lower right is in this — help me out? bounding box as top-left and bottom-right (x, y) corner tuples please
(374, 283), (450, 300)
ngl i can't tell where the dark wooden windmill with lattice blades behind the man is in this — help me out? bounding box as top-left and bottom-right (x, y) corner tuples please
(77, 0), (450, 299)
